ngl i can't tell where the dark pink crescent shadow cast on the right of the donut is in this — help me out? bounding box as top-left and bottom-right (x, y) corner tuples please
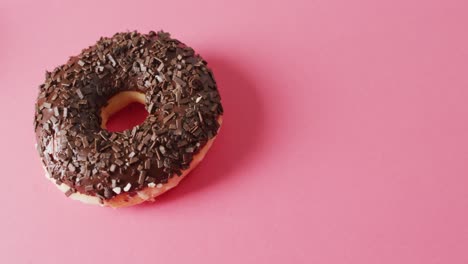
(130, 54), (264, 208)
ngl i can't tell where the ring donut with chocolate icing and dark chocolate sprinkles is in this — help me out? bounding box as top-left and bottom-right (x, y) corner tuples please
(34, 31), (223, 207)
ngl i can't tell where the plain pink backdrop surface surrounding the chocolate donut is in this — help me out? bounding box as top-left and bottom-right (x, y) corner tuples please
(0, 0), (468, 264)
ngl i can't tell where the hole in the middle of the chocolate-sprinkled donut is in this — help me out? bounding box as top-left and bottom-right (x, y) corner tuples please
(101, 91), (148, 132)
